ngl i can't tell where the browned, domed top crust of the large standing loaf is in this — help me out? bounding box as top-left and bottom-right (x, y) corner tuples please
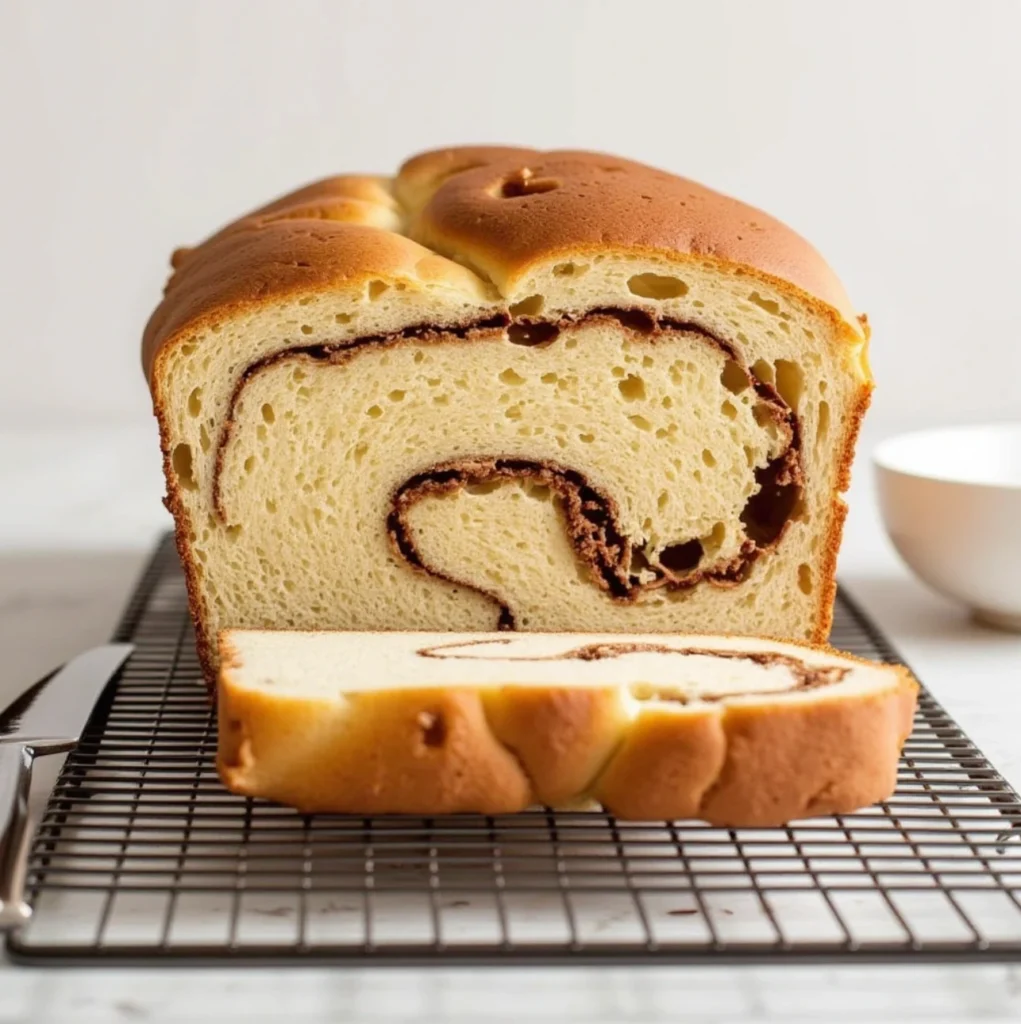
(142, 146), (858, 377)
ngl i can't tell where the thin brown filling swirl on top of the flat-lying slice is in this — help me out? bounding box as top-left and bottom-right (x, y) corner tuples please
(417, 640), (851, 705)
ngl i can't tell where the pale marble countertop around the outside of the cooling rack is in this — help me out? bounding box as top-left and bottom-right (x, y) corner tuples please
(0, 428), (1021, 1024)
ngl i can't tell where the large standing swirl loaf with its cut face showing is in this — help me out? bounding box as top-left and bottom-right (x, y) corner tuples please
(143, 147), (870, 679)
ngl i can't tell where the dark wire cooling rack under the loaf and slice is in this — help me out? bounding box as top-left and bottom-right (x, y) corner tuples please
(8, 539), (1021, 964)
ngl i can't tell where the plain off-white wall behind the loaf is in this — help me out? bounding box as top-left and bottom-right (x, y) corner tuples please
(0, 0), (1021, 430)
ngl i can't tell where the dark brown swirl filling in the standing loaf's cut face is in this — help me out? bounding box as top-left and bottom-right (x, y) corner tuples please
(213, 308), (803, 629)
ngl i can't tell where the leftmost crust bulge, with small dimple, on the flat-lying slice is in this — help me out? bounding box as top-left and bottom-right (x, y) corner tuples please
(217, 683), (530, 814)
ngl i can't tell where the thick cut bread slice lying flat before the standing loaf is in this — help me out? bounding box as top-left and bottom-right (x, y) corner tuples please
(218, 630), (917, 826)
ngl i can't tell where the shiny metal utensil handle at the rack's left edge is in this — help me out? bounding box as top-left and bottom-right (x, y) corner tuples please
(0, 743), (34, 931)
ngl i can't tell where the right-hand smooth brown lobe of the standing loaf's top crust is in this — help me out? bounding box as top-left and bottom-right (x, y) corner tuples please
(409, 150), (854, 322)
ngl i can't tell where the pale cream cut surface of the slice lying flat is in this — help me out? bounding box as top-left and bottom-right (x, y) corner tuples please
(223, 630), (899, 700)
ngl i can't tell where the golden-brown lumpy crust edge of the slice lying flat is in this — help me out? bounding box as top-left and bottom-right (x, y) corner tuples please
(218, 635), (918, 827)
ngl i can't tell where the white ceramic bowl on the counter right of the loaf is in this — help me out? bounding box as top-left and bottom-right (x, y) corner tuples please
(874, 423), (1021, 631)
